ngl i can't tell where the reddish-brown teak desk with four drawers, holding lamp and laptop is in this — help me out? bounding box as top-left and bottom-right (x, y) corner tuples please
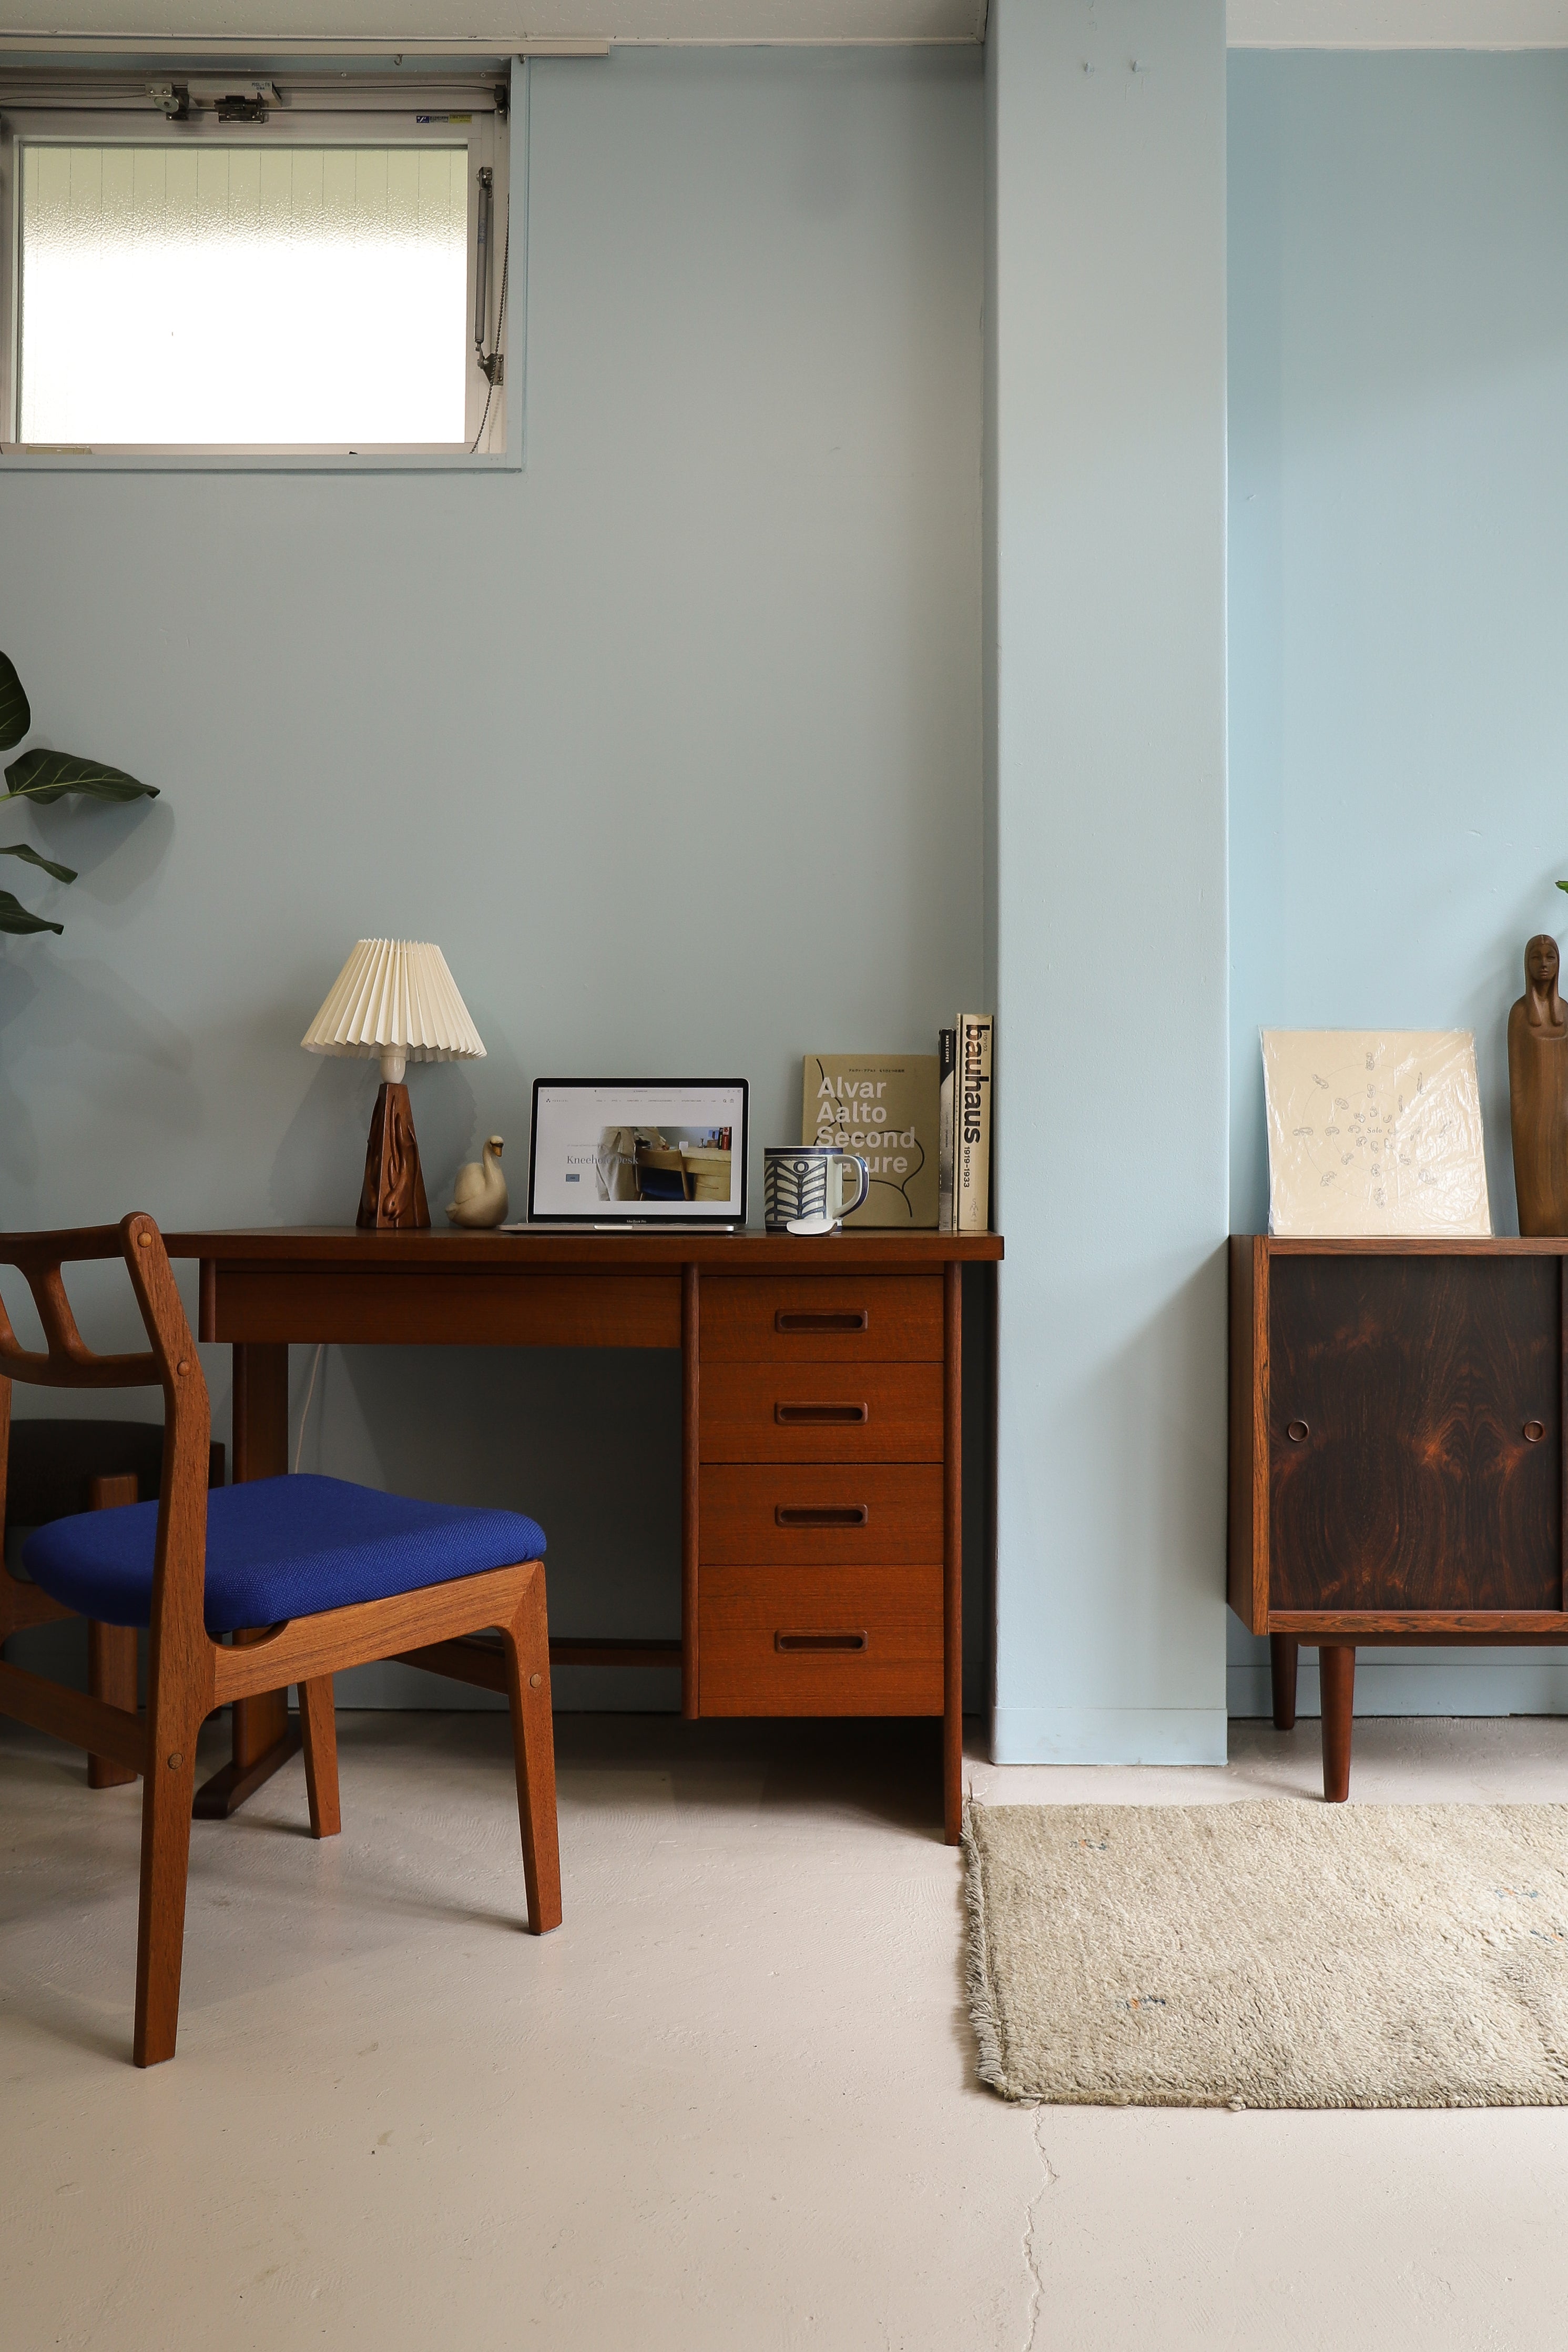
(167, 1228), (1002, 1844)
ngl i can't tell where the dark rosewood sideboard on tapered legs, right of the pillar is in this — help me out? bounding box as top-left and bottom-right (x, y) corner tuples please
(1229, 1235), (1568, 1802)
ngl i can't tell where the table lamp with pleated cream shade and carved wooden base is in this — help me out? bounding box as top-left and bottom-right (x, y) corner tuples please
(299, 938), (484, 1230)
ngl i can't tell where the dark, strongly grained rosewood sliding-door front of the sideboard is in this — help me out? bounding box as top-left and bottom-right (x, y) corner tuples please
(1269, 1254), (1563, 1623)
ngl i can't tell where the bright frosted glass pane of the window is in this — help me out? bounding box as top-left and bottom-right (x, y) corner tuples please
(19, 141), (468, 444)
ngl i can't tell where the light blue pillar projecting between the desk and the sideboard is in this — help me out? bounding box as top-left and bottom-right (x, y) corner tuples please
(987, 0), (1227, 1762)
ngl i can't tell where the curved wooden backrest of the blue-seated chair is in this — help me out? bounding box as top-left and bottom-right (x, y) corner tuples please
(0, 1209), (211, 1635)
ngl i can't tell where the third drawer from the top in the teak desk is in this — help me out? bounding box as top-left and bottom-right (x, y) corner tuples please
(698, 1463), (943, 1566)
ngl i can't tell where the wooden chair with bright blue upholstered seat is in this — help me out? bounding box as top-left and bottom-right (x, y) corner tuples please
(0, 1214), (562, 2065)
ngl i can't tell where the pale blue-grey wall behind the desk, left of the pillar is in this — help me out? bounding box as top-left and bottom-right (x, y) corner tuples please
(0, 52), (983, 1700)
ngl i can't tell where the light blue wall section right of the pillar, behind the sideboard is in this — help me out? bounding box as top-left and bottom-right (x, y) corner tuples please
(1229, 52), (1568, 1712)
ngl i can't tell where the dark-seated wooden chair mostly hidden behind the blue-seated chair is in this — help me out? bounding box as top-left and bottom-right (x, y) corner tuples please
(0, 1421), (223, 1788)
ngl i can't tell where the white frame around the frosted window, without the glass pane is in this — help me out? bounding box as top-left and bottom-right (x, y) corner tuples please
(0, 59), (529, 480)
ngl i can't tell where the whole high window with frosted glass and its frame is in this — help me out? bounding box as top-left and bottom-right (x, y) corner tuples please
(0, 78), (510, 459)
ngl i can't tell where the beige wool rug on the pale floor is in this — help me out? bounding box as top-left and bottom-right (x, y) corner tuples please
(964, 1799), (1568, 2107)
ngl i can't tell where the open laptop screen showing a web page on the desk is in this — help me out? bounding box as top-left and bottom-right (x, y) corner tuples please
(529, 1077), (745, 1225)
